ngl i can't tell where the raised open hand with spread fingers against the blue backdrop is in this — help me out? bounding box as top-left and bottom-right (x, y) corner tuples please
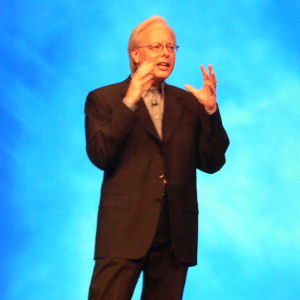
(184, 65), (217, 113)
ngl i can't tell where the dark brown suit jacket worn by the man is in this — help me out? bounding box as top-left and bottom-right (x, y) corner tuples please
(85, 78), (229, 265)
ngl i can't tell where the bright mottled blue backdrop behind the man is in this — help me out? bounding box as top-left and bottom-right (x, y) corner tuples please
(0, 0), (300, 300)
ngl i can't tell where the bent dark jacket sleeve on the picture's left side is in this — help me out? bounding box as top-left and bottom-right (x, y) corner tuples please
(85, 91), (135, 170)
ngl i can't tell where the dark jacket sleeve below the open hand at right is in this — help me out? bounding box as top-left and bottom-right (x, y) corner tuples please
(197, 105), (229, 173)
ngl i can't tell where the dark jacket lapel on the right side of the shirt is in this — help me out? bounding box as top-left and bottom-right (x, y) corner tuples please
(163, 84), (183, 142)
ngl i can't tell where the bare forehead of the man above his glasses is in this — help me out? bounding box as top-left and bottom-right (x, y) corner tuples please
(139, 23), (175, 43)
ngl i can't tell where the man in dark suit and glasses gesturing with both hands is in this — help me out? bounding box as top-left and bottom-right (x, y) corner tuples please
(85, 16), (229, 300)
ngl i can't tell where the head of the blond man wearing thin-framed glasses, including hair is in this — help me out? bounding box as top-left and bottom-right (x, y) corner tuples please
(128, 16), (176, 82)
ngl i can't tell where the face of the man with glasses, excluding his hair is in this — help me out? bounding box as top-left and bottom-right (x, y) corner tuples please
(131, 23), (176, 84)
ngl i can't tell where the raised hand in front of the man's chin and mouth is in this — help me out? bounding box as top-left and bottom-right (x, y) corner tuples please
(125, 61), (155, 104)
